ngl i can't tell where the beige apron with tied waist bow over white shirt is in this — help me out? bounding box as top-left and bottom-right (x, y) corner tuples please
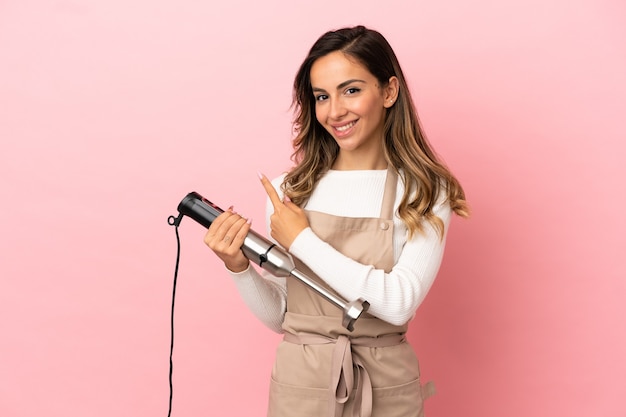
(268, 168), (434, 417)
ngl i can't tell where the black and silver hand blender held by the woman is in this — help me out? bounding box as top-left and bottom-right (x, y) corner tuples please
(173, 192), (369, 331)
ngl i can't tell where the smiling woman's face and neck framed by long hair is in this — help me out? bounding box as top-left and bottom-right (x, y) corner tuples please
(311, 51), (397, 169)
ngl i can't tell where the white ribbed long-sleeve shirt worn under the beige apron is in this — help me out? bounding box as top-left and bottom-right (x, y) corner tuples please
(224, 170), (452, 333)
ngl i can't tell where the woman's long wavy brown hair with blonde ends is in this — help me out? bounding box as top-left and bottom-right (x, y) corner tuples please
(282, 26), (469, 236)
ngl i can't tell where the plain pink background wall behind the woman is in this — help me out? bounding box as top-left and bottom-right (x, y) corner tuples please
(0, 0), (626, 417)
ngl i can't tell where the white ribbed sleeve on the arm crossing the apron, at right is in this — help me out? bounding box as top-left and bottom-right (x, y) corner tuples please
(289, 197), (452, 325)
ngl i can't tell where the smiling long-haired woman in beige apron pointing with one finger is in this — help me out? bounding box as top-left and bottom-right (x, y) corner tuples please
(205, 26), (468, 417)
